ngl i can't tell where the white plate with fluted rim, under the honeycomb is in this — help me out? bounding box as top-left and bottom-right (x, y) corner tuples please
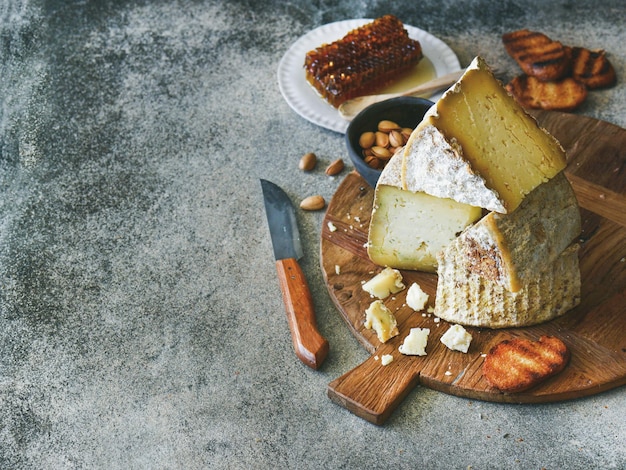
(278, 19), (461, 133)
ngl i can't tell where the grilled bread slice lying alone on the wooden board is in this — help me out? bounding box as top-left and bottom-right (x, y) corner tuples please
(483, 336), (570, 393)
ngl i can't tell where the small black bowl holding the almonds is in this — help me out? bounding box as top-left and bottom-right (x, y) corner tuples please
(345, 96), (434, 188)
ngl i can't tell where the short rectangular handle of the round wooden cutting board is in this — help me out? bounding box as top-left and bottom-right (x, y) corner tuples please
(327, 347), (419, 425)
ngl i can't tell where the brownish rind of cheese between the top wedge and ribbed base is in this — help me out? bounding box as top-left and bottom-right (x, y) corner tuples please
(459, 172), (581, 292)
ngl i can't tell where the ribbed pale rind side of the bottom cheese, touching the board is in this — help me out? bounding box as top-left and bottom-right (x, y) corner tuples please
(434, 240), (580, 328)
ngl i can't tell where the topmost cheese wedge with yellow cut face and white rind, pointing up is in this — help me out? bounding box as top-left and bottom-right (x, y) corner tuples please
(401, 57), (566, 213)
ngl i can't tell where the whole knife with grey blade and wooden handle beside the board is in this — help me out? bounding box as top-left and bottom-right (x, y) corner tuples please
(261, 179), (328, 369)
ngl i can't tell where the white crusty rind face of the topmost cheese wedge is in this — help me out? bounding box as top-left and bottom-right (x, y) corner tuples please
(400, 124), (506, 213)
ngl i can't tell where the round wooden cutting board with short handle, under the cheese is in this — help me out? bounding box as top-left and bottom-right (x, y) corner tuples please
(320, 111), (626, 424)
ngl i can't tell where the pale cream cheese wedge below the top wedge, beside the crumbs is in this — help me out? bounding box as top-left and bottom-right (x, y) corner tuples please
(367, 153), (482, 272)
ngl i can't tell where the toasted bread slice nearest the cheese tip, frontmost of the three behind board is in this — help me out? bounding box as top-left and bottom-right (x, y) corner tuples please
(506, 75), (588, 111)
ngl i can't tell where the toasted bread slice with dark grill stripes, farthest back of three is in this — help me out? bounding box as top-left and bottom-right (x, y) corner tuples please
(502, 29), (571, 81)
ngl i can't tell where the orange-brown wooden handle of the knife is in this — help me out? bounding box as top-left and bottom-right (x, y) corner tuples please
(276, 258), (328, 369)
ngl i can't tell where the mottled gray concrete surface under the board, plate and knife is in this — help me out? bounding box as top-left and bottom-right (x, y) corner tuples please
(0, 0), (626, 470)
